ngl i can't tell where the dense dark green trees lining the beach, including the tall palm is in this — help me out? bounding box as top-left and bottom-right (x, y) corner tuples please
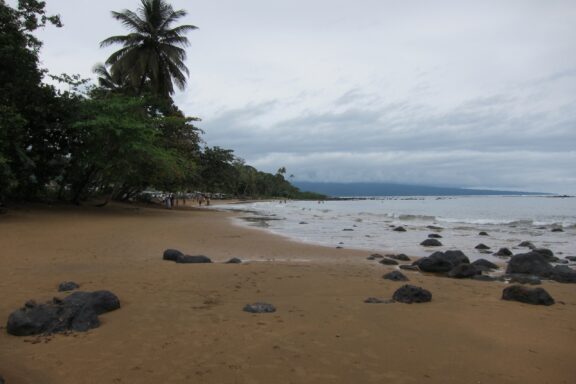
(0, 0), (319, 204)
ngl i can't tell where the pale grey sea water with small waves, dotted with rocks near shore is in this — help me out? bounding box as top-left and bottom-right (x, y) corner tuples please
(218, 196), (576, 260)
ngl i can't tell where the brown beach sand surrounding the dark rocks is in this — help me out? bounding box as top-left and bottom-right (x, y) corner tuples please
(0, 202), (576, 384)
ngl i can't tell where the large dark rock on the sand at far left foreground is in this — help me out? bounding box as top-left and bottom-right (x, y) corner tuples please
(6, 291), (120, 336)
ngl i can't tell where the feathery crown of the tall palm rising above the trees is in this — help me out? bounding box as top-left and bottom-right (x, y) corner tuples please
(100, 0), (197, 97)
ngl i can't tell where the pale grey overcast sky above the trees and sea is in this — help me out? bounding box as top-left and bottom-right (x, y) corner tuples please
(24, 0), (576, 193)
